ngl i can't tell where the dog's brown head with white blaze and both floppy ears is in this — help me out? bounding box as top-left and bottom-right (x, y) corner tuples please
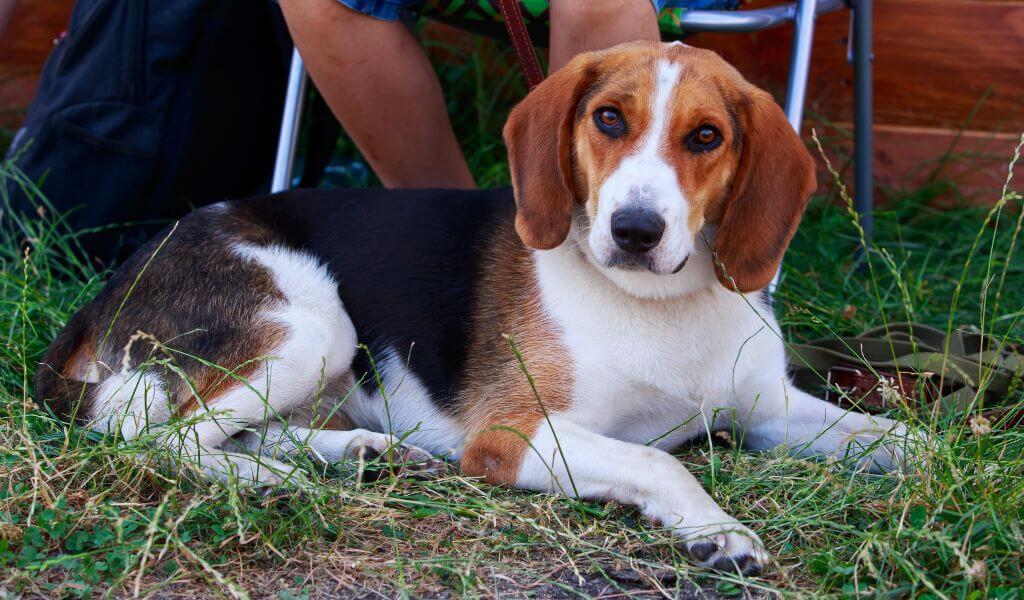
(505, 42), (815, 295)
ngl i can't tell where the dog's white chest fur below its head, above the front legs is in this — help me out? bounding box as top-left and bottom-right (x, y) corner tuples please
(540, 245), (775, 446)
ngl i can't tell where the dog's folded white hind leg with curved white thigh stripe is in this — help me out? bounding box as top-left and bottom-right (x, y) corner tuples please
(92, 249), (356, 487)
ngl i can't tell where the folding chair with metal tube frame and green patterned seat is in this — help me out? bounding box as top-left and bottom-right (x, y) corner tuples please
(271, 0), (872, 234)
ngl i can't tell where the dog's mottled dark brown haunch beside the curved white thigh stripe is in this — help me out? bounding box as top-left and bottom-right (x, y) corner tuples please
(36, 202), (288, 421)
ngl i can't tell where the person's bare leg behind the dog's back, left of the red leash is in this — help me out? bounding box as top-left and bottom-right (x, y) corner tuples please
(281, 0), (476, 188)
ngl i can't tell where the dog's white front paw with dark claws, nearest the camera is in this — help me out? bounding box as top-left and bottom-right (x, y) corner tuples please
(675, 513), (768, 575)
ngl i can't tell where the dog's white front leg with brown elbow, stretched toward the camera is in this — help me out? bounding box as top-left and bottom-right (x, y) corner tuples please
(463, 416), (768, 574)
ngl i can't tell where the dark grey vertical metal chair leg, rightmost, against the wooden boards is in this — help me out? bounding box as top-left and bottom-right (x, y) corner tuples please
(851, 0), (874, 240)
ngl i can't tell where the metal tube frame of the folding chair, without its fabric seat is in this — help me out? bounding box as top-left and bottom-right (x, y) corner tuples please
(270, 0), (873, 235)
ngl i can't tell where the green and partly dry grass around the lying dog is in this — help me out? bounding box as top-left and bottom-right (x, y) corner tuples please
(0, 33), (1024, 598)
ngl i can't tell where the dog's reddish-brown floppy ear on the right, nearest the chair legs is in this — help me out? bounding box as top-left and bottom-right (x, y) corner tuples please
(714, 87), (817, 293)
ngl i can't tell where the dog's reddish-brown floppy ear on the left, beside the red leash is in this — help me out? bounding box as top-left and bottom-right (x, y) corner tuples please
(504, 54), (597, 250)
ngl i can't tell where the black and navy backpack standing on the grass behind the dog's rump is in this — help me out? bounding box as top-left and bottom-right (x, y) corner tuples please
(8, 0), (291, 264)
